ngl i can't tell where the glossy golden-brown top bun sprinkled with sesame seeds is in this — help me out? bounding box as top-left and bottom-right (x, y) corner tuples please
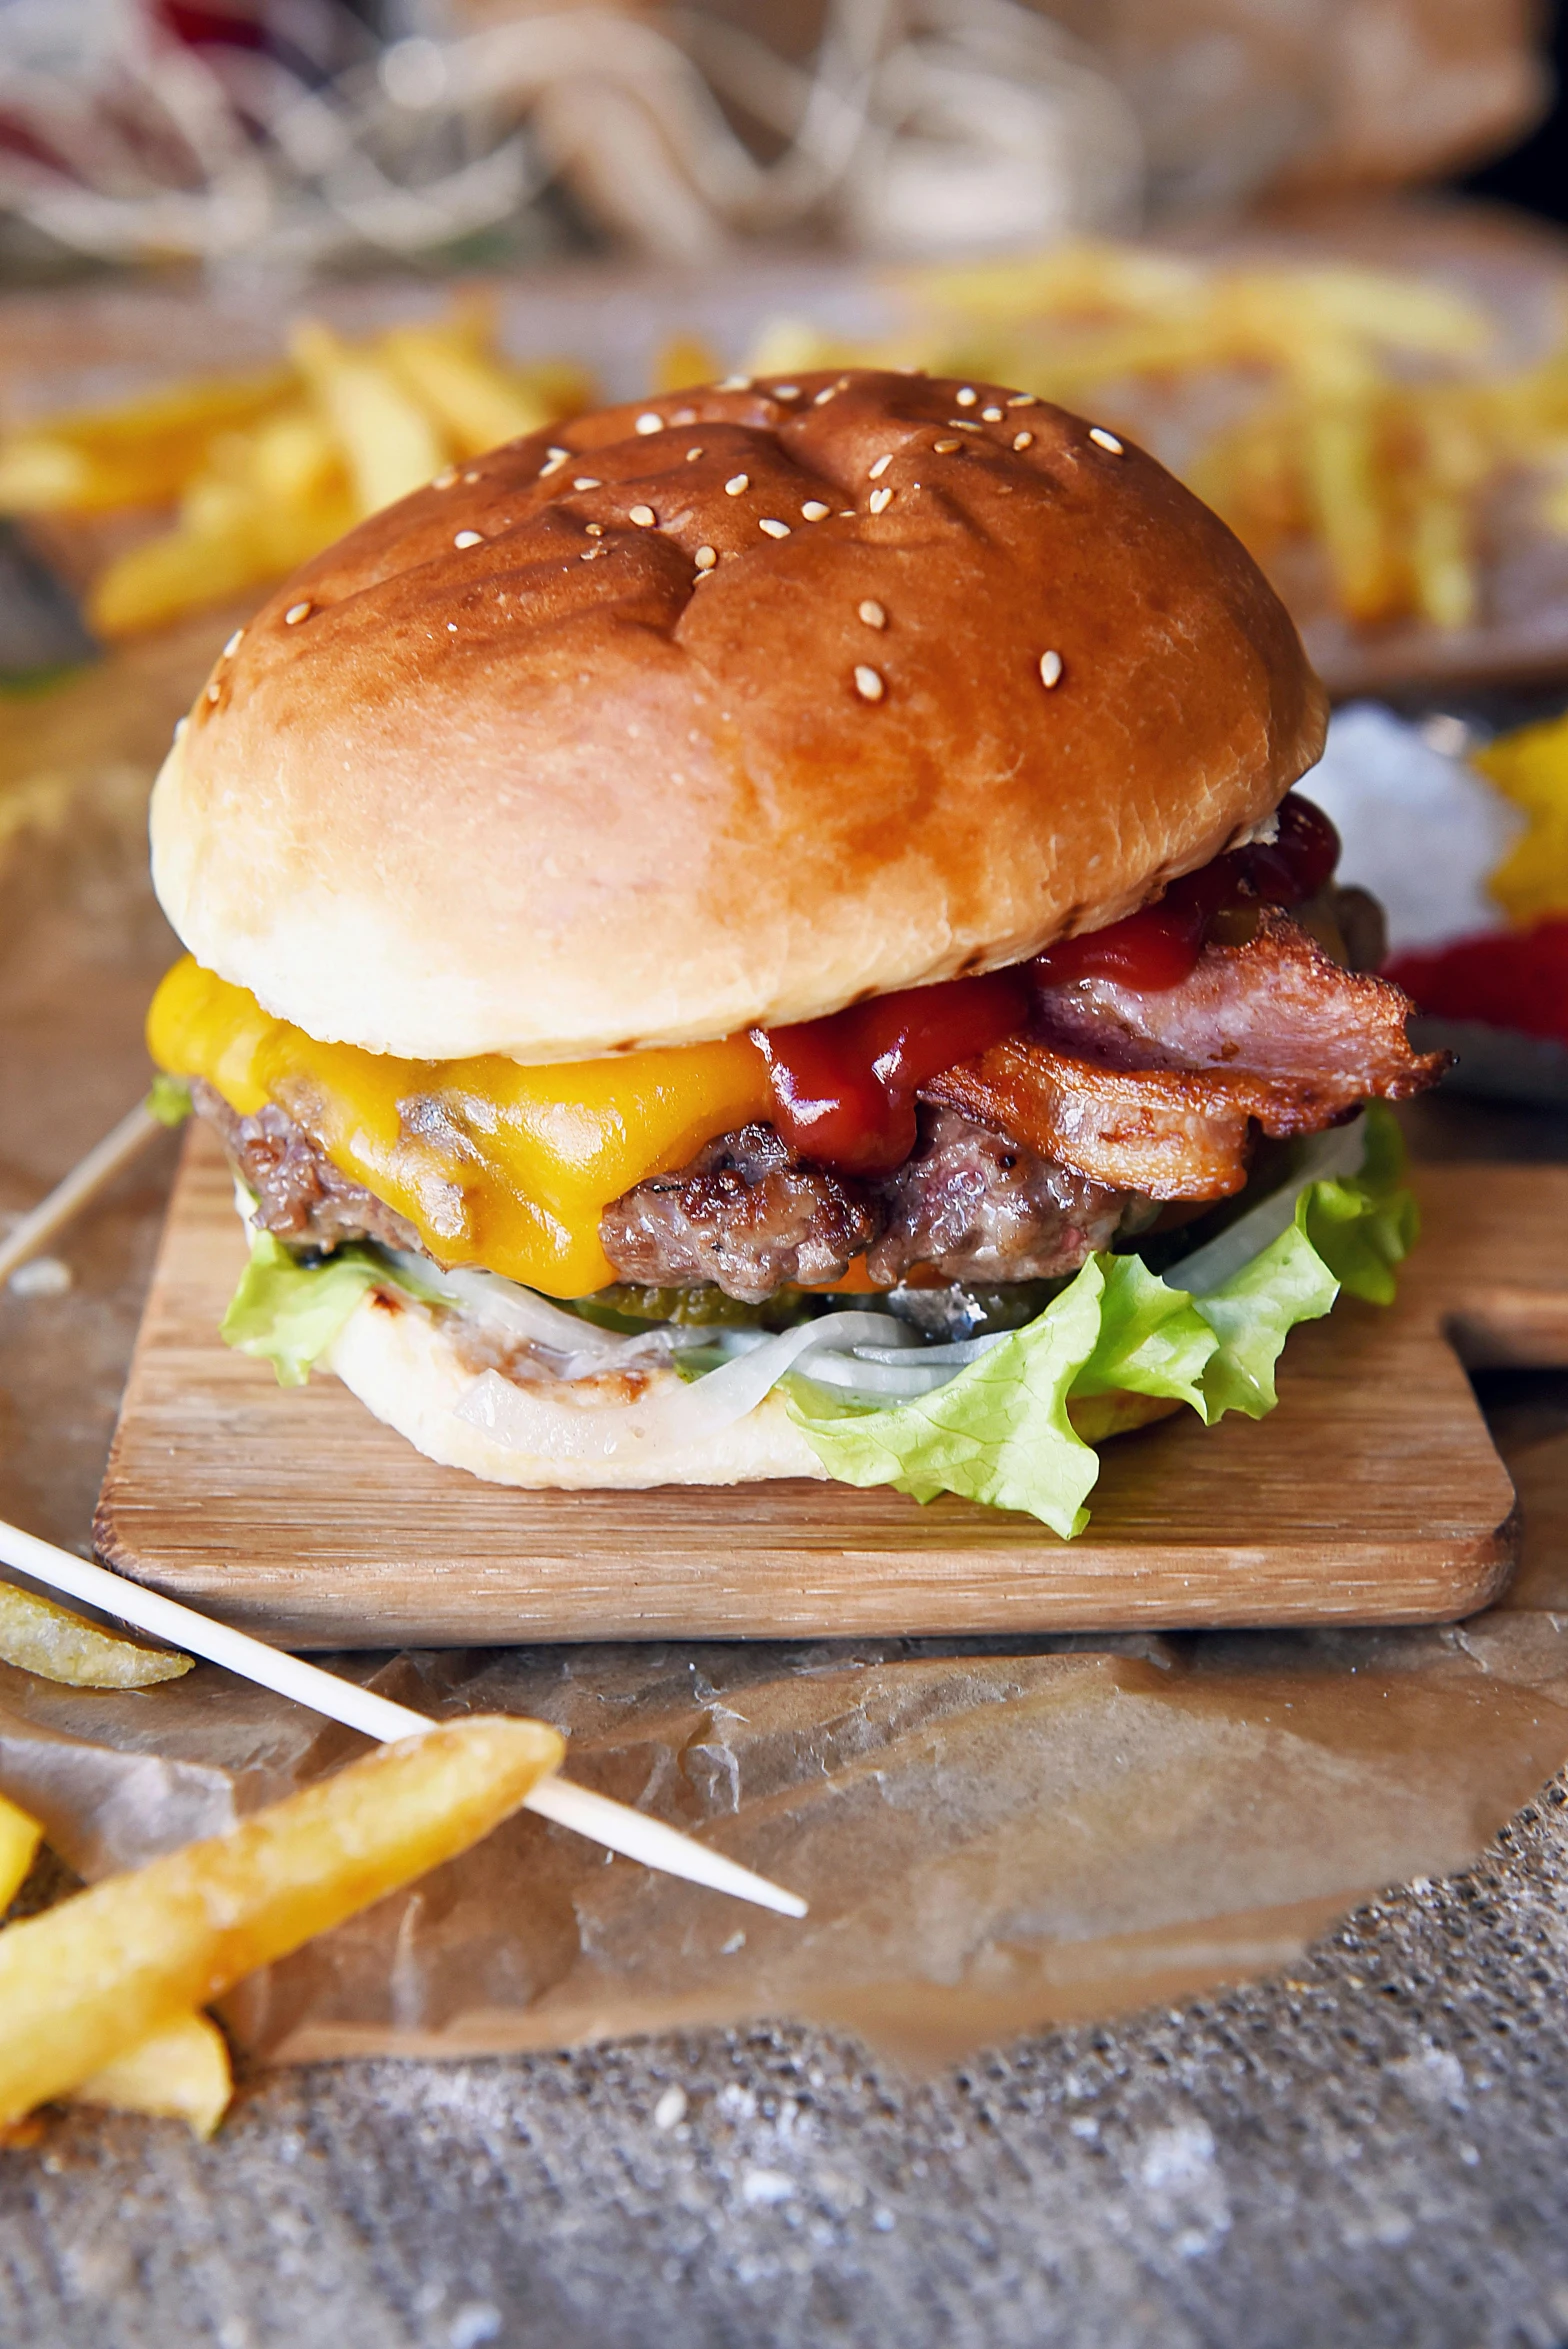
(153, 371), (1324, 1062)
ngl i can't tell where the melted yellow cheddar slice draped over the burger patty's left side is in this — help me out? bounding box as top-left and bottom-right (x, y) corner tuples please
(148, 956), (772, 1297)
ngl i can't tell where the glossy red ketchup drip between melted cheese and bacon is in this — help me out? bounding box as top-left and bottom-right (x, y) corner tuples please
(751, 970), (1033, 1175)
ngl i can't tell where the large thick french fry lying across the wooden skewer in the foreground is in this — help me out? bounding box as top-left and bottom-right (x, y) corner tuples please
(0, 1715), (563, 2123)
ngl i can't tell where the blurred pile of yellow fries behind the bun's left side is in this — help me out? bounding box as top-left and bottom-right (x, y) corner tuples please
(0, 301), (592, 639)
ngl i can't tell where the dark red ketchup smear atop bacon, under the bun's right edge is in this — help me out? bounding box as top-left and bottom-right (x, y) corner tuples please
(1030, 792), (1340, 989)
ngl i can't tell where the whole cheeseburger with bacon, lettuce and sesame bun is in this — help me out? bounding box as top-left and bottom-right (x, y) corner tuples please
(148, 371), (1441, 1534)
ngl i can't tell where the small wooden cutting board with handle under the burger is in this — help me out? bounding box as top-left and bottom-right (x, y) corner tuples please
(96, 1128), (1568, 1647)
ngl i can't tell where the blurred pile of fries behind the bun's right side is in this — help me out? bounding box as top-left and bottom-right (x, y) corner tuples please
(751, 244), (1568, 630)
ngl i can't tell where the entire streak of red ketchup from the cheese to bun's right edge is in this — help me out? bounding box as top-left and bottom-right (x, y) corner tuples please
(751, 796), (1340, 1175)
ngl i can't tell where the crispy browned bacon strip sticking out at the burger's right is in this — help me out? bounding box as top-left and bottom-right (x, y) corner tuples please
(922, 914), (1446, 1200)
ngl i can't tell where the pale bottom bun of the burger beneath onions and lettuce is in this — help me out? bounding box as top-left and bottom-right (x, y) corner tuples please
(324, 1292), (1181, 1492)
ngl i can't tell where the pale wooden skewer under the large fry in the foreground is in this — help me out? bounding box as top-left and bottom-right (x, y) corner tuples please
(0, 1520), (805, 1917)
